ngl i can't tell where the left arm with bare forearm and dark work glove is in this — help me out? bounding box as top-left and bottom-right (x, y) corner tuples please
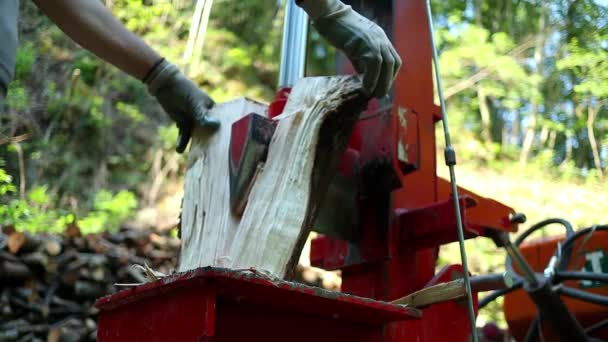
(34, 0), (219, 153)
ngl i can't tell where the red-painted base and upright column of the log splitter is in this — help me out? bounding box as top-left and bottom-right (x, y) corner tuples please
(98, 0), (517, 342)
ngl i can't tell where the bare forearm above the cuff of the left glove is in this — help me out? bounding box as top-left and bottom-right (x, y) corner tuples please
(34, 0), (160, 79)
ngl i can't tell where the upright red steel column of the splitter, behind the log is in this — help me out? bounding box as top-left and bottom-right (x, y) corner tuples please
(311, 0), (517, 341)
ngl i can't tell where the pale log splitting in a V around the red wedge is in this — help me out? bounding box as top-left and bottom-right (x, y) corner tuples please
(178, 76), (367, 278)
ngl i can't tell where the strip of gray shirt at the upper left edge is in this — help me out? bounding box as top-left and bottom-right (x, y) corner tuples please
(0, 0), (19, 106)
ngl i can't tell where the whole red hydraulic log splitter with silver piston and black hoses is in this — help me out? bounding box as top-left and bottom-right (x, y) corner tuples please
(97, 0), (608, 342)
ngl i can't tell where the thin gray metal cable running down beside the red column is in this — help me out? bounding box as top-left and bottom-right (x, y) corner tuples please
(426, 0), (479, 342)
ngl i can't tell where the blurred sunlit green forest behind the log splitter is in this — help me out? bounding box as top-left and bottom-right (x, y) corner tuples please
(0, 0), (608, 323)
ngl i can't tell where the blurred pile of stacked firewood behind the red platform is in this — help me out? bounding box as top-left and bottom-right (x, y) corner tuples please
(0, 226), (180, 342)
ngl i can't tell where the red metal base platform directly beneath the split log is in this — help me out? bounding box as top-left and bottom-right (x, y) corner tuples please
(96, 268), (421, 342)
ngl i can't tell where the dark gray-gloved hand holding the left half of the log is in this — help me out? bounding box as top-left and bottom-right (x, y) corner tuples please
(143, 59), (220, 153)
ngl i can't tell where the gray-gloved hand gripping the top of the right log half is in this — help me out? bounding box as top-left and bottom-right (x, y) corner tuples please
(296, 0), (401, 97)
